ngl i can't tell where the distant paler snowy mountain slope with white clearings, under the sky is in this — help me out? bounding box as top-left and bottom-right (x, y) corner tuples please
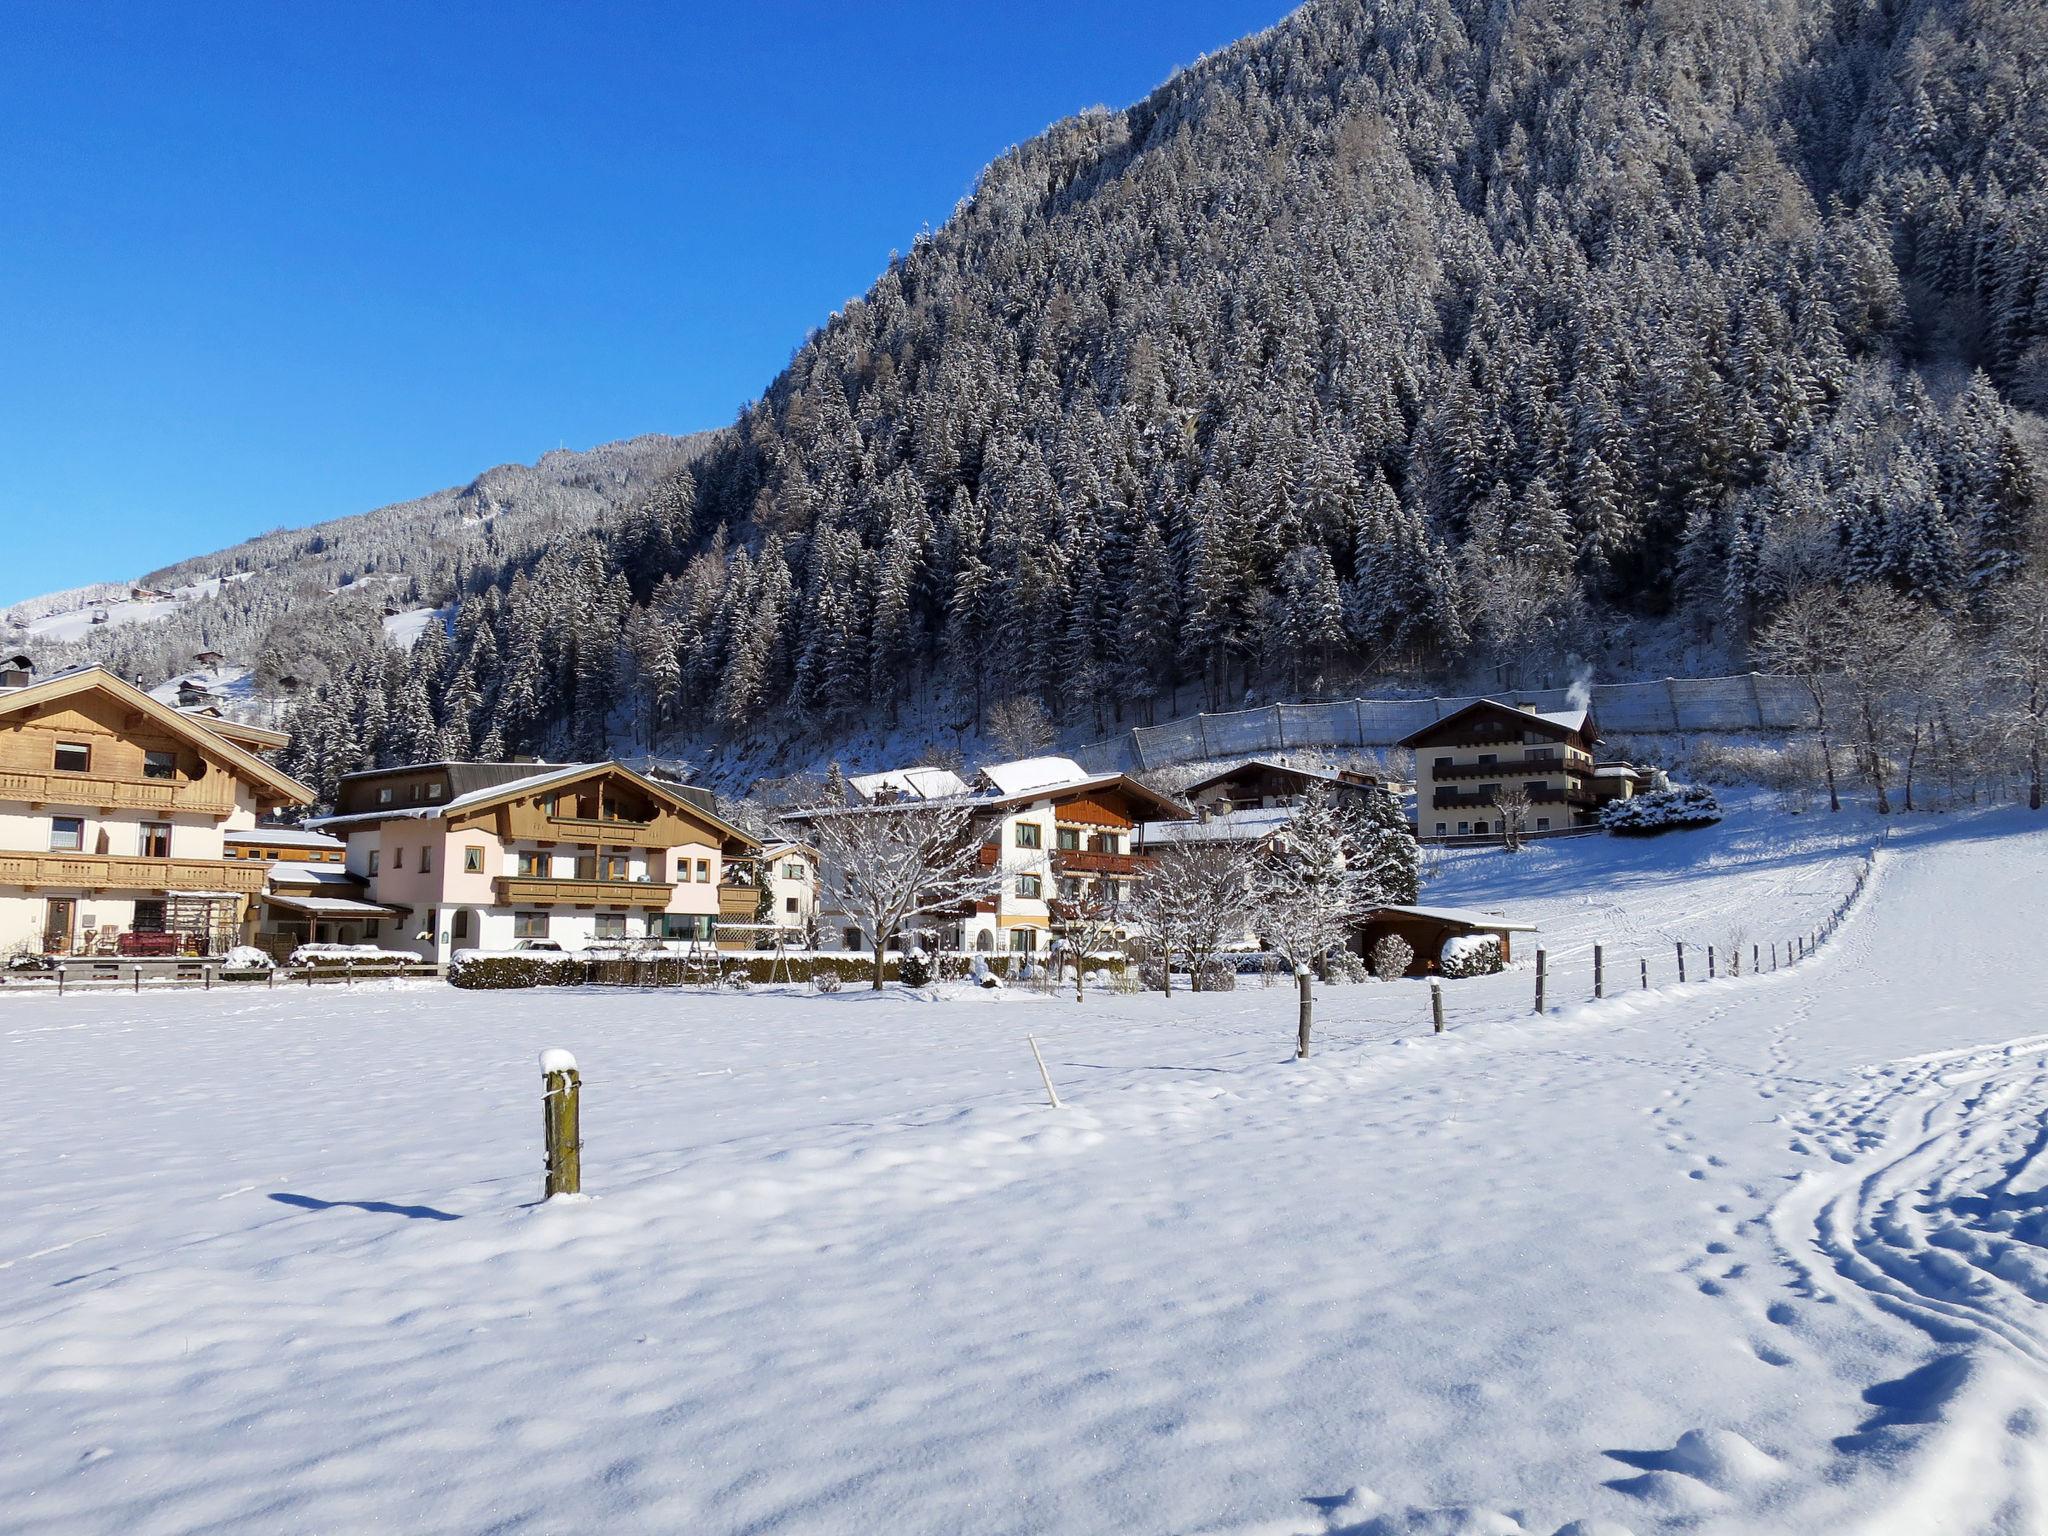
(10, 432), (715, 688)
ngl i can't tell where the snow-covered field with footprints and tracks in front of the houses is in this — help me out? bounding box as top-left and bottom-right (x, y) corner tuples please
(0, 807), (2048, 1536)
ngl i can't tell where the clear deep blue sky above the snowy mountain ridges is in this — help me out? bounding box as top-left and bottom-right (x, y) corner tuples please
(0, 0), (1290, 604)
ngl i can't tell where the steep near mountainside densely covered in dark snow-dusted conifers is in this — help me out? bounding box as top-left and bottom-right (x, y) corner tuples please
(276, 0), (2048, 798)
